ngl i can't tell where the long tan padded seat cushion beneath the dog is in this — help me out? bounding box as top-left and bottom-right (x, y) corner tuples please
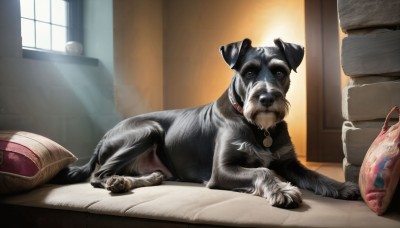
(0, 182), (400, 228)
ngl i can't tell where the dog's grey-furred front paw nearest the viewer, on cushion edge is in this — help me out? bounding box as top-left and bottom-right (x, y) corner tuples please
(266, 182), (302, 208)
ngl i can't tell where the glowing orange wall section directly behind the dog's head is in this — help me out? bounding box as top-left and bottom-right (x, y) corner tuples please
(164, 0), (306, 156)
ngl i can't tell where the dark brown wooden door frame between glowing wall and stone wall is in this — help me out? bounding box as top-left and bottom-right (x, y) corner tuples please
(305, 0), (344, 162)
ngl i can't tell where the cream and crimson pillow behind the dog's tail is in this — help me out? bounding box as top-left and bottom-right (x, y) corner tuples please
(0, 131), (77, 194)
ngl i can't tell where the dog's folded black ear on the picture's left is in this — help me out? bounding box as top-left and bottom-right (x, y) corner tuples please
(219, 38), (251, 69)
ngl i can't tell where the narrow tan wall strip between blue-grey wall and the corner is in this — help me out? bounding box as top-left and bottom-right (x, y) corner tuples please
(114, 0), (164, 117)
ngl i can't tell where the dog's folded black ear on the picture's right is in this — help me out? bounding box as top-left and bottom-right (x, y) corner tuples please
(274, 39), (304, 73)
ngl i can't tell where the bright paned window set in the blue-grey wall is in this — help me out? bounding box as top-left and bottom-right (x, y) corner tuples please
(20, 0), (82, 52)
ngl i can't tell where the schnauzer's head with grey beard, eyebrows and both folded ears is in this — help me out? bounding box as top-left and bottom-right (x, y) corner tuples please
(220, 39), (304, 130)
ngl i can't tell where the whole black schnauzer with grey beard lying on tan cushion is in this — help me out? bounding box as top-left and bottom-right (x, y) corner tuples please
(55, 39), (359, 208)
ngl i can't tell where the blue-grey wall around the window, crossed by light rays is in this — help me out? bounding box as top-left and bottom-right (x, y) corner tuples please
(0, 0), (119, 163)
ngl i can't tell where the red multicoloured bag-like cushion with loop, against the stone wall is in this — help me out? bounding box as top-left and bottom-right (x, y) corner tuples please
(359, 107), (400, 215)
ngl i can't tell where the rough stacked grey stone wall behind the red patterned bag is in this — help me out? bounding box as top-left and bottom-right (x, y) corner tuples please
(338, 0), (400, 182)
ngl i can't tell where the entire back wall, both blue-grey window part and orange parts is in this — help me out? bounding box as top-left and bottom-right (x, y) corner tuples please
(0, 0), (306, 162)
